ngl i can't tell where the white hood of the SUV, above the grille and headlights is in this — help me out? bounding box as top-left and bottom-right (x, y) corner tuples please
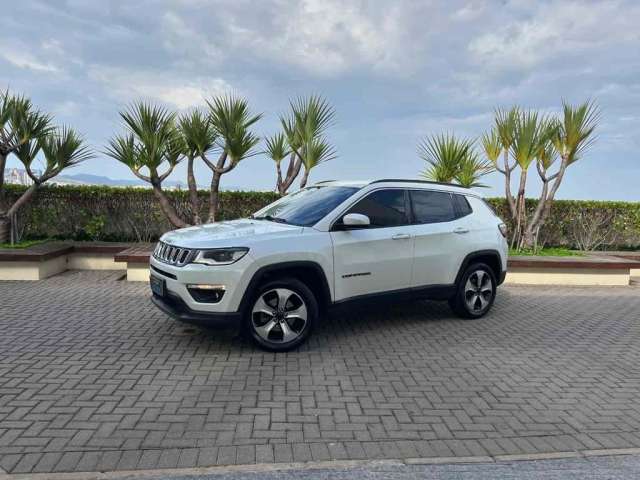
(160, 219), (303, 248)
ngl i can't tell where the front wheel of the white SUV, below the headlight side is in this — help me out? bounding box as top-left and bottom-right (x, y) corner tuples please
(246, 278), (318, 352)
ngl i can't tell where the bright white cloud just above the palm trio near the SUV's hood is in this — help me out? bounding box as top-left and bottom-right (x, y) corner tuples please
(88, 65), (233, 109)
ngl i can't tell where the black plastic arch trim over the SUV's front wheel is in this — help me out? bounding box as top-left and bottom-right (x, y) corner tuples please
(239, 260), (331, 312)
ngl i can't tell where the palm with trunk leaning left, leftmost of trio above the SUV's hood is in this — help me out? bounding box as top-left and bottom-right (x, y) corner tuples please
(105, 102), (188, 228)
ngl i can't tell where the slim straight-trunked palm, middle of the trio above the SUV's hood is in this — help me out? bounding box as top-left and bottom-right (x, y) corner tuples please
(178, 109), (218, 225)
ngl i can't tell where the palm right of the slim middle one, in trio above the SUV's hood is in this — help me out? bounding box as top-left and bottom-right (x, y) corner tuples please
(202, 95), (262, 223)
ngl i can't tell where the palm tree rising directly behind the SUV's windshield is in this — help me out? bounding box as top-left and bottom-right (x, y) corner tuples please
(276, 95), (336, 195)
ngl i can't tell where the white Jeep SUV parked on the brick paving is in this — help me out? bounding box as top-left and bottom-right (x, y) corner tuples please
(150, 179), (507, 351)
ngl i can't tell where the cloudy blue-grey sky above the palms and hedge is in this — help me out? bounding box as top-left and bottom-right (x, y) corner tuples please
(0, 0), (640, 201)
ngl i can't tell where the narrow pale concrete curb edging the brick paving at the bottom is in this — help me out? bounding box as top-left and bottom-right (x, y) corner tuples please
(0, 448), (640, 480)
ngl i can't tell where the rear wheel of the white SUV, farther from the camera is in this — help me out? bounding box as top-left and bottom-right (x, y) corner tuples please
(449, 263), (497, 318)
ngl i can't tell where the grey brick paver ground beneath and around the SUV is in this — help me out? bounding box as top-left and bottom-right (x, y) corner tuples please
(0, 272), (640, 473)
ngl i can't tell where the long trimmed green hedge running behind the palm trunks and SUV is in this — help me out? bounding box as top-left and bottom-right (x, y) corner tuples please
(6, 185), (640, 249)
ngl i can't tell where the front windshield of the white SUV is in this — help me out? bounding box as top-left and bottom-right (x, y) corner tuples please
(251, 186), (359, 227)
